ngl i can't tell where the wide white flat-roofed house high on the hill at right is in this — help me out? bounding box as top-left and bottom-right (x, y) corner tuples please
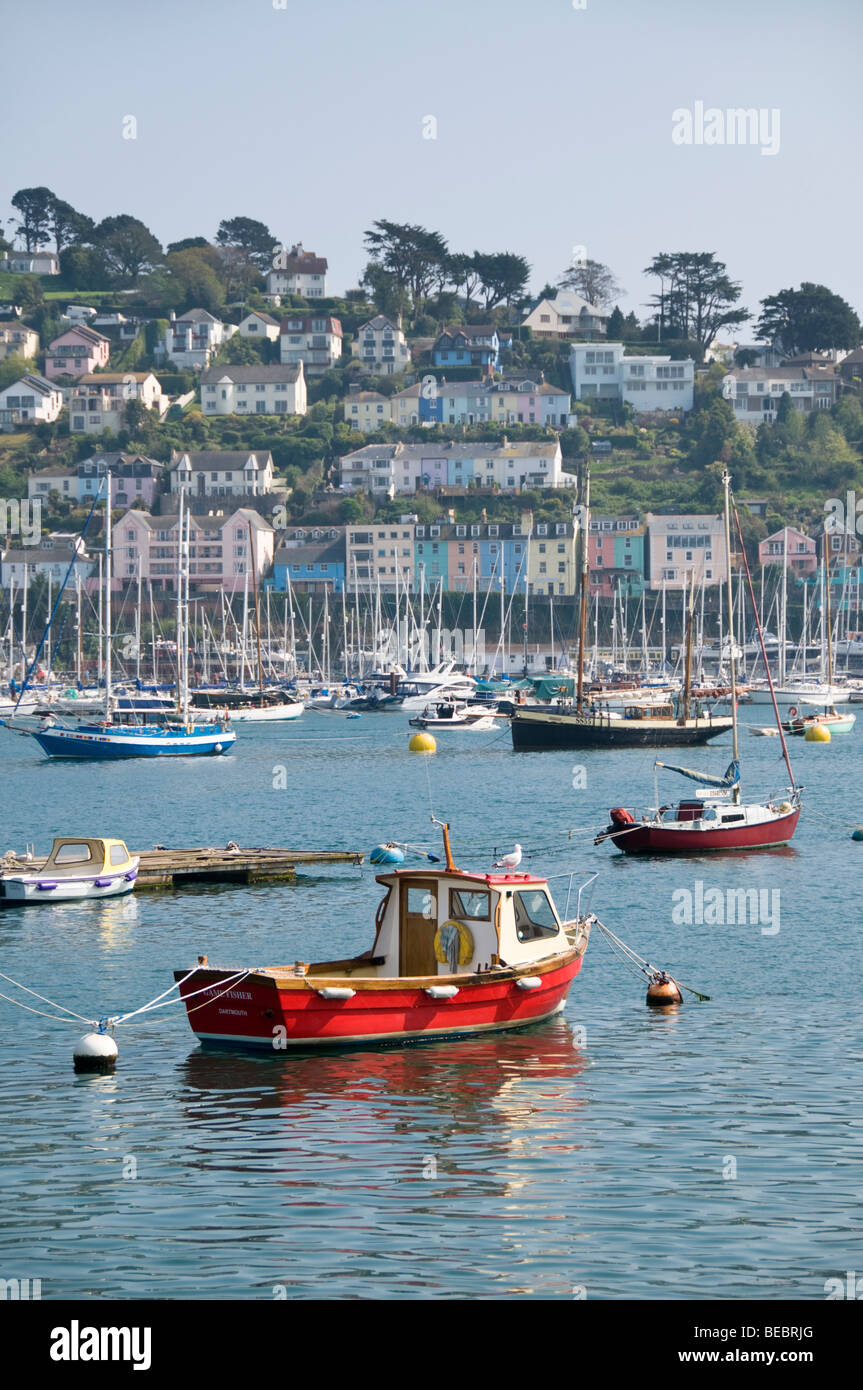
(570, 343), (695, 411)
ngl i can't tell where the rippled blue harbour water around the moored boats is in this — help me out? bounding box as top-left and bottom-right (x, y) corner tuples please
(0, 710), (863, 1298)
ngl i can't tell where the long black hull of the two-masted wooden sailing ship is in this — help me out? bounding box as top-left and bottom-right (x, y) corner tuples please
(510, 710), (732, 749)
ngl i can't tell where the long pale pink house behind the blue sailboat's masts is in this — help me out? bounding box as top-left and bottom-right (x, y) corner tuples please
(114, 507), (275, 594)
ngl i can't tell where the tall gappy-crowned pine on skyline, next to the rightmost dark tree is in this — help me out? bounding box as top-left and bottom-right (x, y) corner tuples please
(645, 252), (752, 353)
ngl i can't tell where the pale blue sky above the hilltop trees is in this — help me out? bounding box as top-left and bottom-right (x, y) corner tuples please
(0, 0), (863, 338)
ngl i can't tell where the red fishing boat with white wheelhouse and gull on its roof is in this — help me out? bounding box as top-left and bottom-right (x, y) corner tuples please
(174, 826), (593, 1049)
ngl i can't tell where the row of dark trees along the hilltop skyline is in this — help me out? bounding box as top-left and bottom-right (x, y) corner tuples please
(4, 188), (862, 357)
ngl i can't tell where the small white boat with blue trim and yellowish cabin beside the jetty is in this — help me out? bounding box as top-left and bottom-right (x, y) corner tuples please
(0, 835), (139, 902)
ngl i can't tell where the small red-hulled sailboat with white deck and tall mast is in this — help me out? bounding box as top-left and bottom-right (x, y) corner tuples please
(593, 470), (800, 855)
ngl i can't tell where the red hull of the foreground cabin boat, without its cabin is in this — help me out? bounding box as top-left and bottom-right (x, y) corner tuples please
(176, 954), (584, 1051)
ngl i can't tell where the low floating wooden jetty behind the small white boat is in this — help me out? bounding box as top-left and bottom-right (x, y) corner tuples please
(0, 842), (364, 892)
